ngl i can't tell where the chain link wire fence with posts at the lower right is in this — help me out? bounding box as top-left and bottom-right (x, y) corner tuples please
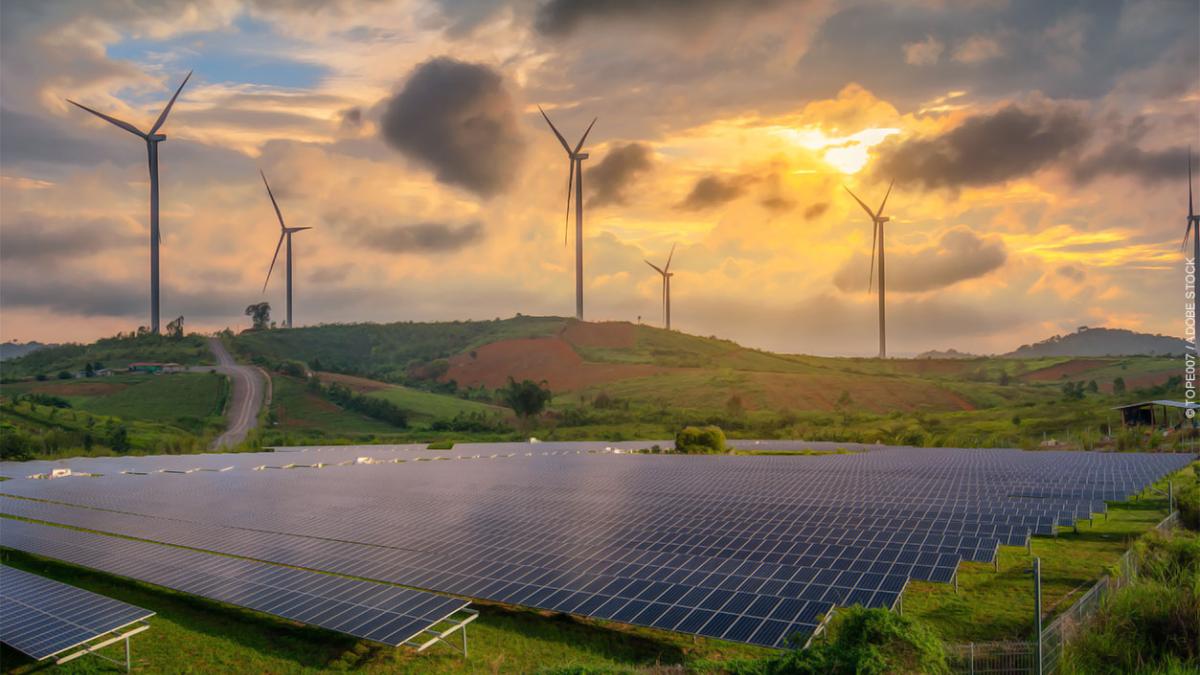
(946, 512), (1180, 675)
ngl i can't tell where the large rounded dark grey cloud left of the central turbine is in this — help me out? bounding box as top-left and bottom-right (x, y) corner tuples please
(380, 56), (524, 196)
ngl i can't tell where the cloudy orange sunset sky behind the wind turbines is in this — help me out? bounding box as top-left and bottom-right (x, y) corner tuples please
(0, 0), (1200, 356)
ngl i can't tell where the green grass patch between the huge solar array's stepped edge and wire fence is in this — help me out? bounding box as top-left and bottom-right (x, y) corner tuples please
(904, 470), (1190, 643)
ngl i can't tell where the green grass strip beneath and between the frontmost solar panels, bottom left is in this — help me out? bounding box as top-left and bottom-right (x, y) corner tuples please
(0, 551), (768, 674)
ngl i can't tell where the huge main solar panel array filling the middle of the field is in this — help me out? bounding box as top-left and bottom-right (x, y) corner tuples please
(0, 443), (1189, 646)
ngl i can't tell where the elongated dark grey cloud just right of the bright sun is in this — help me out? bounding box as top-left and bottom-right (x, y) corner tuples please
(875, 103), (1092, 189)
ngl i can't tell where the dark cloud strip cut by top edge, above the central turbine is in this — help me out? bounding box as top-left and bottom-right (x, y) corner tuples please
(534, 0), (782, 36)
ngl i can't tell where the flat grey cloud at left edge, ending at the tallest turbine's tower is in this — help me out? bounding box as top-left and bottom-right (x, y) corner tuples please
(0, 213), (146, 263)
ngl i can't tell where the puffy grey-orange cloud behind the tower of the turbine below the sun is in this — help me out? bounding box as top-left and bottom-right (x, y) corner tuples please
(834, 227), (1008, 293)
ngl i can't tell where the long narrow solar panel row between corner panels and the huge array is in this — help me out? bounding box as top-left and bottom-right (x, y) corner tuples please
(4, 520), (468, 643)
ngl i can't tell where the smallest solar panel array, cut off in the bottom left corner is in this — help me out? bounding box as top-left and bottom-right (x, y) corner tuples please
(0, 562), (154, 661)
